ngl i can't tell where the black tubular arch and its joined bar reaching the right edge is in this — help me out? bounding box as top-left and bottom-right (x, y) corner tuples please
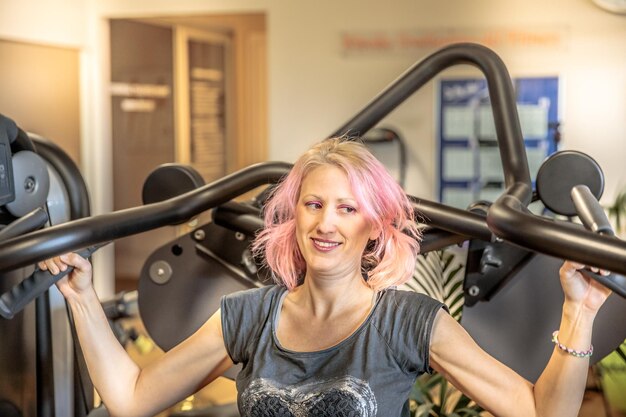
(333, 43), (626, 274)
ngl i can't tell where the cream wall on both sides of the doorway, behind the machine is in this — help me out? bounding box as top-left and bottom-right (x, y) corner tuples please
(0, 0), (626, 292)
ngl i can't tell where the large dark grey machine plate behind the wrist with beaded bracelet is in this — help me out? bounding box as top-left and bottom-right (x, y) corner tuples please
(461, 254), (626, 382)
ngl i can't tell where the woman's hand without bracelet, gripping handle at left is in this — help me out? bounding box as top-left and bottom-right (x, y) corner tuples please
(37, 252), (92, 298)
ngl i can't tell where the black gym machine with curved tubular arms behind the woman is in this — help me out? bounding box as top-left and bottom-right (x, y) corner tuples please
(0, 44), (626, 416)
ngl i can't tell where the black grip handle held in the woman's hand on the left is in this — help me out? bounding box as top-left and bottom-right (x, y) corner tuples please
(0, 245), (102, 319)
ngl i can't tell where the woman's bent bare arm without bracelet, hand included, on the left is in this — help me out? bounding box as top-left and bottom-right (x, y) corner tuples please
(40, 254), (232, 417)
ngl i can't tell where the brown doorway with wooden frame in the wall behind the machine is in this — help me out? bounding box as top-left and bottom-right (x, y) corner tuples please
(110, 14), (267, 291)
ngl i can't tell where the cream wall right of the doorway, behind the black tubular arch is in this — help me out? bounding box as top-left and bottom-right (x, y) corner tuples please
(268, 0), (626, 202)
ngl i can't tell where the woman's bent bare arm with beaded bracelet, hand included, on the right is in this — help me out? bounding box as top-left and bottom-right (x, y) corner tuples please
(430, 262), (610, 417)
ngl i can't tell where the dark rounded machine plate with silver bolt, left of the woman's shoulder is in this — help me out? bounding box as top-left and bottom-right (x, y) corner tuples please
(137, 223), (254, 351)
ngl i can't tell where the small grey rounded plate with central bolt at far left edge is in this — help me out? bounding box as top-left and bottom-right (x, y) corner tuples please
(6, 151), (50, 217)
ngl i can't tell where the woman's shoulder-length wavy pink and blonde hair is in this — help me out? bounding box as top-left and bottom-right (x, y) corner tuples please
(252, 137), (421, 290)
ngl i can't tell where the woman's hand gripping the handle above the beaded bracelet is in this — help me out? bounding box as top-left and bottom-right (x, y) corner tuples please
(559, 261), (611, 311)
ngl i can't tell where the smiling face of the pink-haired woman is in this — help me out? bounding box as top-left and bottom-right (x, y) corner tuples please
(296, 165), (377, 277)
